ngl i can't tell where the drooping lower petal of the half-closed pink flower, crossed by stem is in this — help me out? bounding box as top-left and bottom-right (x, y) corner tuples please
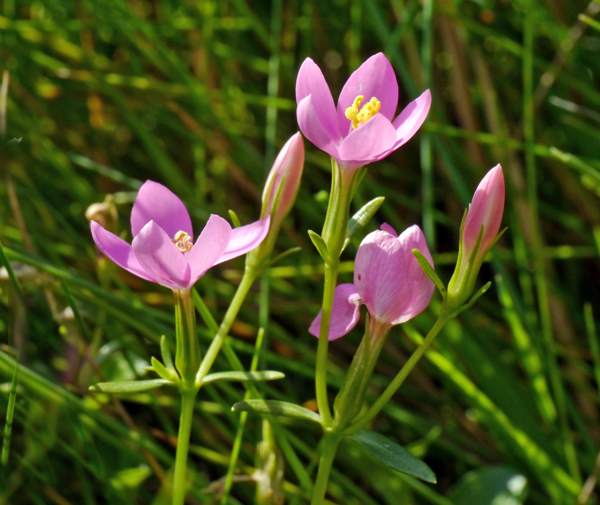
(308, 284), (360, 340)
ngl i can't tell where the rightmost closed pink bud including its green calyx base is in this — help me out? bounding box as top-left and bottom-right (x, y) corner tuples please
(448, 165), (505, 308)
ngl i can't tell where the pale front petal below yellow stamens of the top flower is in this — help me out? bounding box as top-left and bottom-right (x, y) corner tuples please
(337, 114), (396, 165)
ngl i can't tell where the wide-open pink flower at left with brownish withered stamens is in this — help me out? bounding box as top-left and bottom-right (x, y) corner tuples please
(90, 181), (270, 290)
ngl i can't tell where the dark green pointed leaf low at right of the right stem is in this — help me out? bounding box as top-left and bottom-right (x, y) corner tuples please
(346, 430), (437, 484)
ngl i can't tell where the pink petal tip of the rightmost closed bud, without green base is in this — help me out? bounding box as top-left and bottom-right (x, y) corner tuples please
(462, 164), (505, 255)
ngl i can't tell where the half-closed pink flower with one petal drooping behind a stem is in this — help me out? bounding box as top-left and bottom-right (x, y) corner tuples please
(309, 224), (434, 340)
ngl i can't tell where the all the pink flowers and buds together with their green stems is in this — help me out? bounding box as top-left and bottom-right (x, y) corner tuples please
(89, 53), (505, 505)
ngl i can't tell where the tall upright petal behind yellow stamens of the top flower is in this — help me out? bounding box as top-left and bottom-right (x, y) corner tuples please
(337, 53), (398, 134)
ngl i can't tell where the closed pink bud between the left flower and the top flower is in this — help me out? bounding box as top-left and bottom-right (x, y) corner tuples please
(262, 132), (304, 226)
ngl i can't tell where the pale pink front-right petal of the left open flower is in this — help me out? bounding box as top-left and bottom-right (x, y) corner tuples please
(186, 214), (232, 284)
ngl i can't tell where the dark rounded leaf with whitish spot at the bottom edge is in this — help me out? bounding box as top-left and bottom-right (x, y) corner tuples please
(450, 466), (527, 505)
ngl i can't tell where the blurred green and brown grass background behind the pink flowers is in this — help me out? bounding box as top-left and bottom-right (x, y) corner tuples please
(0, 0), (600, 505)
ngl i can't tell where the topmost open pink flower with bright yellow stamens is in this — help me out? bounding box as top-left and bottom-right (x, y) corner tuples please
(296, 53), (431, 169)
